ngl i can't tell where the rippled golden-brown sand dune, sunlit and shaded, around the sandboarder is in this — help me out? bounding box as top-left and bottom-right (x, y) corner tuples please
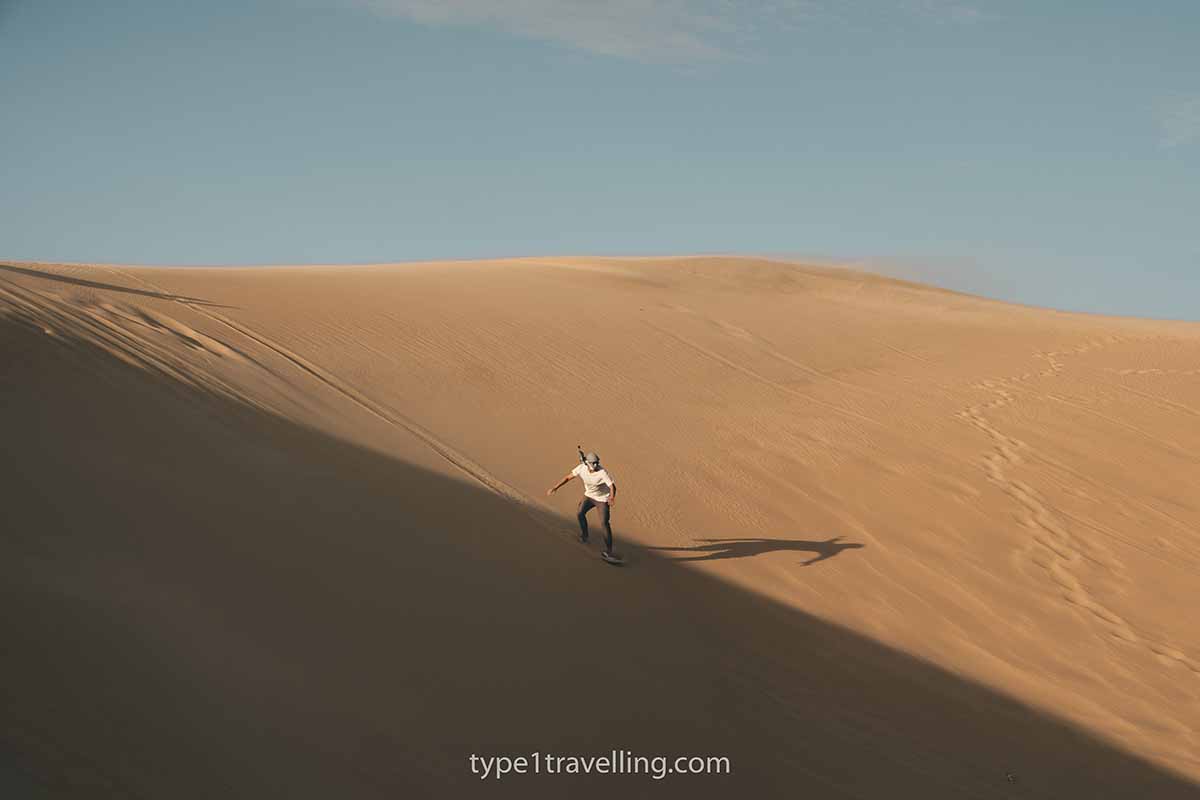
(0, 258), (1200, 799)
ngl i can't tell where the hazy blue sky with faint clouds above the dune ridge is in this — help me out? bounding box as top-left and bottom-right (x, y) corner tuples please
(0, 0), (1200, 319)
